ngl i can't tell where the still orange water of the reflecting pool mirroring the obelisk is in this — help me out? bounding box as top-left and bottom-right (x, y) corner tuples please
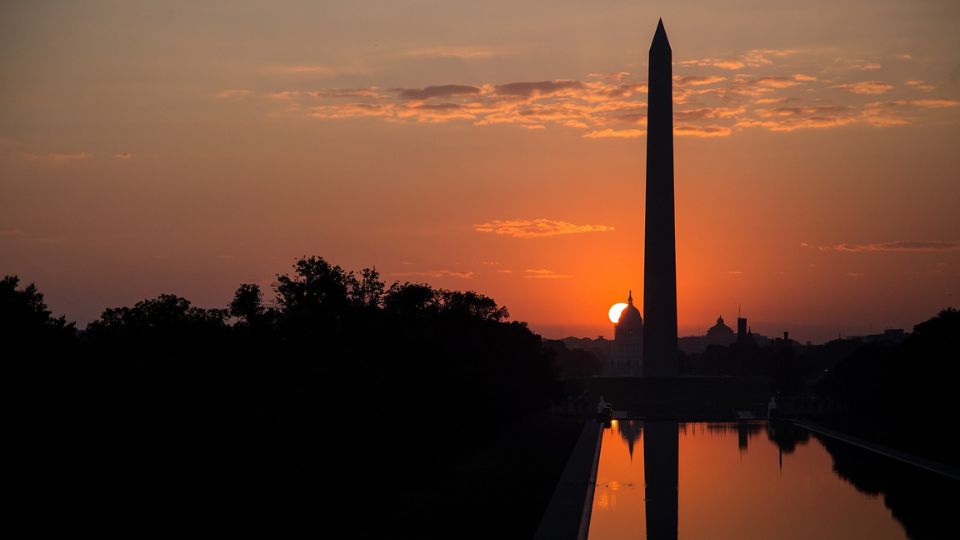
(589, 420), (944, 540)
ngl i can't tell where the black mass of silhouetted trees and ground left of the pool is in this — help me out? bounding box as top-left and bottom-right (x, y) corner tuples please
(0, 258), (580, 538)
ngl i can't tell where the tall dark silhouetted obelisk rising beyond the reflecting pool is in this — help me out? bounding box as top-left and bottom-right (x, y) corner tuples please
(643, 19), (679, 377)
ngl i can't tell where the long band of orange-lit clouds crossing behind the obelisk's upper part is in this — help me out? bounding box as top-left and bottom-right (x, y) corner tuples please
(231, 47), (958, 140)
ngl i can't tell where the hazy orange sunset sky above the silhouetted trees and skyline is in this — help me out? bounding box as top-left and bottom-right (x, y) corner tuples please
(0, 0), (960, 342)
